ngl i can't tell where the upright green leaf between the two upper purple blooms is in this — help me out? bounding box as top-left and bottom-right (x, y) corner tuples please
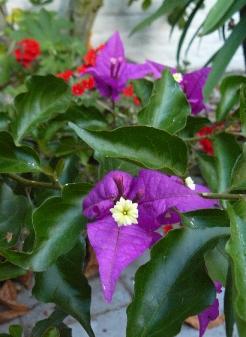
(138, 70), (190, 133)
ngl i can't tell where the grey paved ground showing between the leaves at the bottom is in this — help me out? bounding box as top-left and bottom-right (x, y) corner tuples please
(0, 258), (237, 337)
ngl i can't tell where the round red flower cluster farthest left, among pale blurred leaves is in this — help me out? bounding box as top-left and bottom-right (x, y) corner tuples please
(14, 39), (41, 68)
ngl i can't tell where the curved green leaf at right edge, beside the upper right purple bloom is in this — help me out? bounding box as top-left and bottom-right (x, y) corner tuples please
(216, 75), (246, 121)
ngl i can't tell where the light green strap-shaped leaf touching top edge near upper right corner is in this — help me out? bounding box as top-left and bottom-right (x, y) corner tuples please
(201, 0), (235, 35)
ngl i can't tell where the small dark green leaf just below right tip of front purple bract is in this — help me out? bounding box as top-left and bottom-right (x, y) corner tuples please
(181, 208), (230, 229)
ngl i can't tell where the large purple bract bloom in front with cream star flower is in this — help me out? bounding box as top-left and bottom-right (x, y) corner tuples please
(83, 170), (216, 302)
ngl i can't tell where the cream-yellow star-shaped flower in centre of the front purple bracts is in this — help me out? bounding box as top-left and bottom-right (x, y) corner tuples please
(110, 197), (138, 227)
